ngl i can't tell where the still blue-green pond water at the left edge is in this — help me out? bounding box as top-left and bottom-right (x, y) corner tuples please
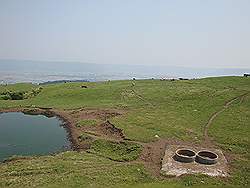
(0, 112), (70, 162)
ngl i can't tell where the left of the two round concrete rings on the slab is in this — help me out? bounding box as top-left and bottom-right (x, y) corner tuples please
(174, 149), (195, 163)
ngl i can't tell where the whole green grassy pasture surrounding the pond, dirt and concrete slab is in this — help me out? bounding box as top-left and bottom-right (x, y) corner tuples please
(0, 77), (250, 188)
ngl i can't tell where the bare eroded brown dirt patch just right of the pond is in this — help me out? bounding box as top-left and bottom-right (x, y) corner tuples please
(51, 108), (124, 150)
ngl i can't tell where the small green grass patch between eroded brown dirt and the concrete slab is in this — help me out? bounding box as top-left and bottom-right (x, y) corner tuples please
(88, 140), (142, 161)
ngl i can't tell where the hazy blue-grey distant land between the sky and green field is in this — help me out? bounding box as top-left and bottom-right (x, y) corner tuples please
(0, 59), (250, 83)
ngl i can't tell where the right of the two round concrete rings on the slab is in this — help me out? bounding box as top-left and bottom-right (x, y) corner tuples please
(195, 151), (218, 165)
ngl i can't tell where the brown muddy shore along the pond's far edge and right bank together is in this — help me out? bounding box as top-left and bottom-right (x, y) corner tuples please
(0, 107), (125, 151)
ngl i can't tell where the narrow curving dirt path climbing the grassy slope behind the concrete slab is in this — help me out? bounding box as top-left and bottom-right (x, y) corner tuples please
(203, 92), (249, 145)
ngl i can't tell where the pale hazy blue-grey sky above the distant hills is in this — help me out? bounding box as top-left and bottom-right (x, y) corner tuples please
(0, 0), (250, 68)
